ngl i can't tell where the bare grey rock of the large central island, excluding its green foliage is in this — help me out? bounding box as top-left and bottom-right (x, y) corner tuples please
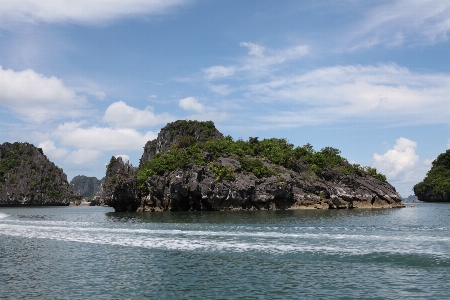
(103, 121), (404, 211)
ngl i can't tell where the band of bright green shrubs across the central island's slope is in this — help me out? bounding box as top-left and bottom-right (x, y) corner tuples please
(138, 136), (386, 193)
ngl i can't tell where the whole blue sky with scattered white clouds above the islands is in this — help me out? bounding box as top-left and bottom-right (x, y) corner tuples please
(0, 0), (450, 197)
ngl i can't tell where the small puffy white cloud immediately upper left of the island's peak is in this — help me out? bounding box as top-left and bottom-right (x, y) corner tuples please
(103, 101), (175, 128)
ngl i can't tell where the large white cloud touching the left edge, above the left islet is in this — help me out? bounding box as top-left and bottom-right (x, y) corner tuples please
(0, 66), (90, 123)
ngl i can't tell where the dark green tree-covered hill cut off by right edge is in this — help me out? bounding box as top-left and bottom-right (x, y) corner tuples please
(414, 149), (450, 202)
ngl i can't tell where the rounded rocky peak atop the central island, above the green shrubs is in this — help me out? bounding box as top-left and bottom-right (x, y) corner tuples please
(139, 120), (223, 166)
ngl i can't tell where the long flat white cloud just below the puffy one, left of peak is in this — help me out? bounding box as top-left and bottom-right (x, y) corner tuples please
(51, 122), (157, 151)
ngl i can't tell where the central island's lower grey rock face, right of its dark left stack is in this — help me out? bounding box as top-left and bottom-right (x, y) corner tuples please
(137, 157), (403, 211)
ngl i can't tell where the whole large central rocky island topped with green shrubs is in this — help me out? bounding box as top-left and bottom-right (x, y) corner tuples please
(103, 121), (403, 211)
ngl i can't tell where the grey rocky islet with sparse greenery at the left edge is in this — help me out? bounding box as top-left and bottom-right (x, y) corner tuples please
(0, 142), (73, 206)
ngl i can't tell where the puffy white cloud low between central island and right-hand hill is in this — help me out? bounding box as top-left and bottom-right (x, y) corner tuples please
(373, 137), (419, 181)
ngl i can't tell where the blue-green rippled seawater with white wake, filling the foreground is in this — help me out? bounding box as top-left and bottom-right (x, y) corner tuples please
(0, 203), (450, 299)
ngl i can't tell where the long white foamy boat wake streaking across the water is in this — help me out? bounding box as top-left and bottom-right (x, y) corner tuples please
(0, 222), (450, 259)
